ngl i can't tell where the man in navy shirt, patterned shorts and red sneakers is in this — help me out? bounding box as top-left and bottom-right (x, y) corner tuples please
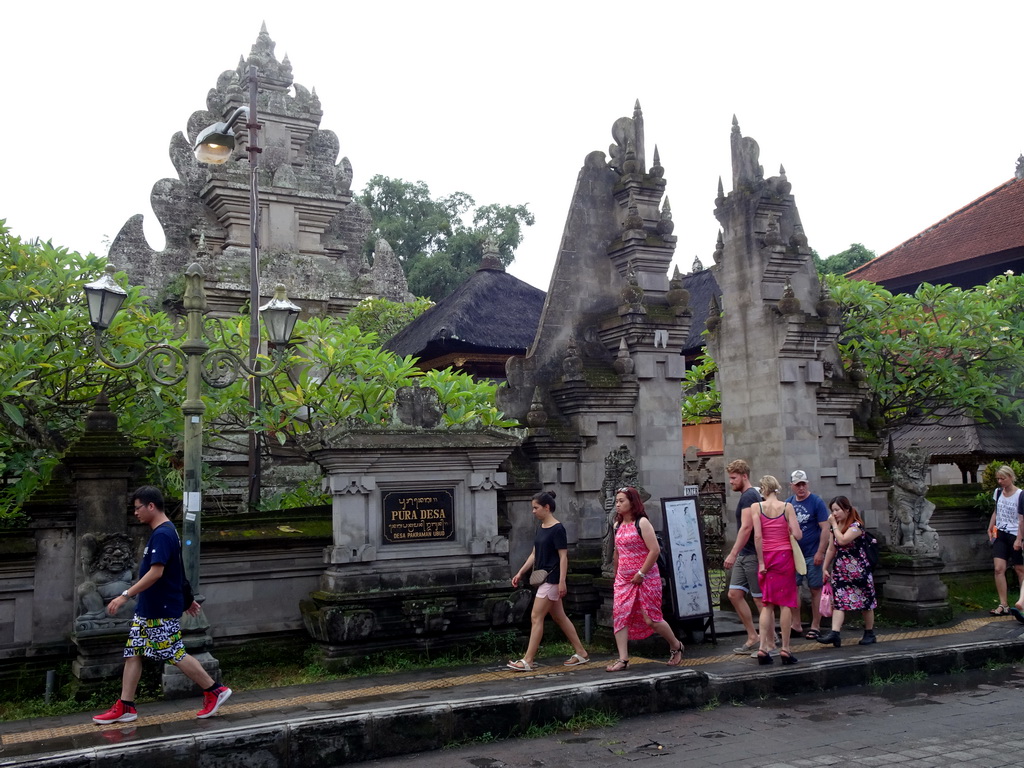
(92, 485), (231, 724)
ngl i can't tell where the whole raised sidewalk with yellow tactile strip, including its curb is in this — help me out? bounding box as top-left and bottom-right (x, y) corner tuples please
(0, 614), (1024, 768)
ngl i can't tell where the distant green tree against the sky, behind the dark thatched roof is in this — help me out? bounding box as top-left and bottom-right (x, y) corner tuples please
(359, 175), (535, 301)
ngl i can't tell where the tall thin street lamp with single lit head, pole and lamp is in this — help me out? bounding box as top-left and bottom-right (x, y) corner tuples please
(194, 66), (263, 508)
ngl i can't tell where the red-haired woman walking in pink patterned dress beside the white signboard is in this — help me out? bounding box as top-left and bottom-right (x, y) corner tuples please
(605, 486), (683, 672)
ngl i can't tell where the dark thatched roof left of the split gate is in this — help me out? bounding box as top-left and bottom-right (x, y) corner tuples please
(384, 257), (547, 358)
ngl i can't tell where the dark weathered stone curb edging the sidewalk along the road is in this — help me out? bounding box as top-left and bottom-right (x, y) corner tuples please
(12, 637), (1024, 768)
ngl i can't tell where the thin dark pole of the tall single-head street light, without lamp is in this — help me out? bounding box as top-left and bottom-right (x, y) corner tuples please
(246, 67), (262, 509)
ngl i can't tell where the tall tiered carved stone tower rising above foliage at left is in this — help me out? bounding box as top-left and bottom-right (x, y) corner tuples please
(110, 26), (412, 314)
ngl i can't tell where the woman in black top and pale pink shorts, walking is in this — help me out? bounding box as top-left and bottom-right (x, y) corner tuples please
(508, 492), (590, 672)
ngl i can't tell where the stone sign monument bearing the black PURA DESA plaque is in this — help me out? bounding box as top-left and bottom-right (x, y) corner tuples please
(300, 423), (531, 669)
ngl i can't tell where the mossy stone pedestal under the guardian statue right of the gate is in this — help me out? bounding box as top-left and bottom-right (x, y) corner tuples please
(881, 554), (950, 625)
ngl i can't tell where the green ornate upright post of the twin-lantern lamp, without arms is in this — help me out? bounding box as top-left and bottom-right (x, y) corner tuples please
(181, 264), (210, 594)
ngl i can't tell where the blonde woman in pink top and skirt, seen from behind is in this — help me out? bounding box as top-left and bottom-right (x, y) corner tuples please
(751, 475), (803, 664)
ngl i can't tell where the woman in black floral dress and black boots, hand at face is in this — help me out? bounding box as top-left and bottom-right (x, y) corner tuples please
(818, 496), (878, 648)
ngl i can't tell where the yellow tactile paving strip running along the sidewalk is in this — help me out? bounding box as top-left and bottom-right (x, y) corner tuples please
(0, 616), (1006, 744)
